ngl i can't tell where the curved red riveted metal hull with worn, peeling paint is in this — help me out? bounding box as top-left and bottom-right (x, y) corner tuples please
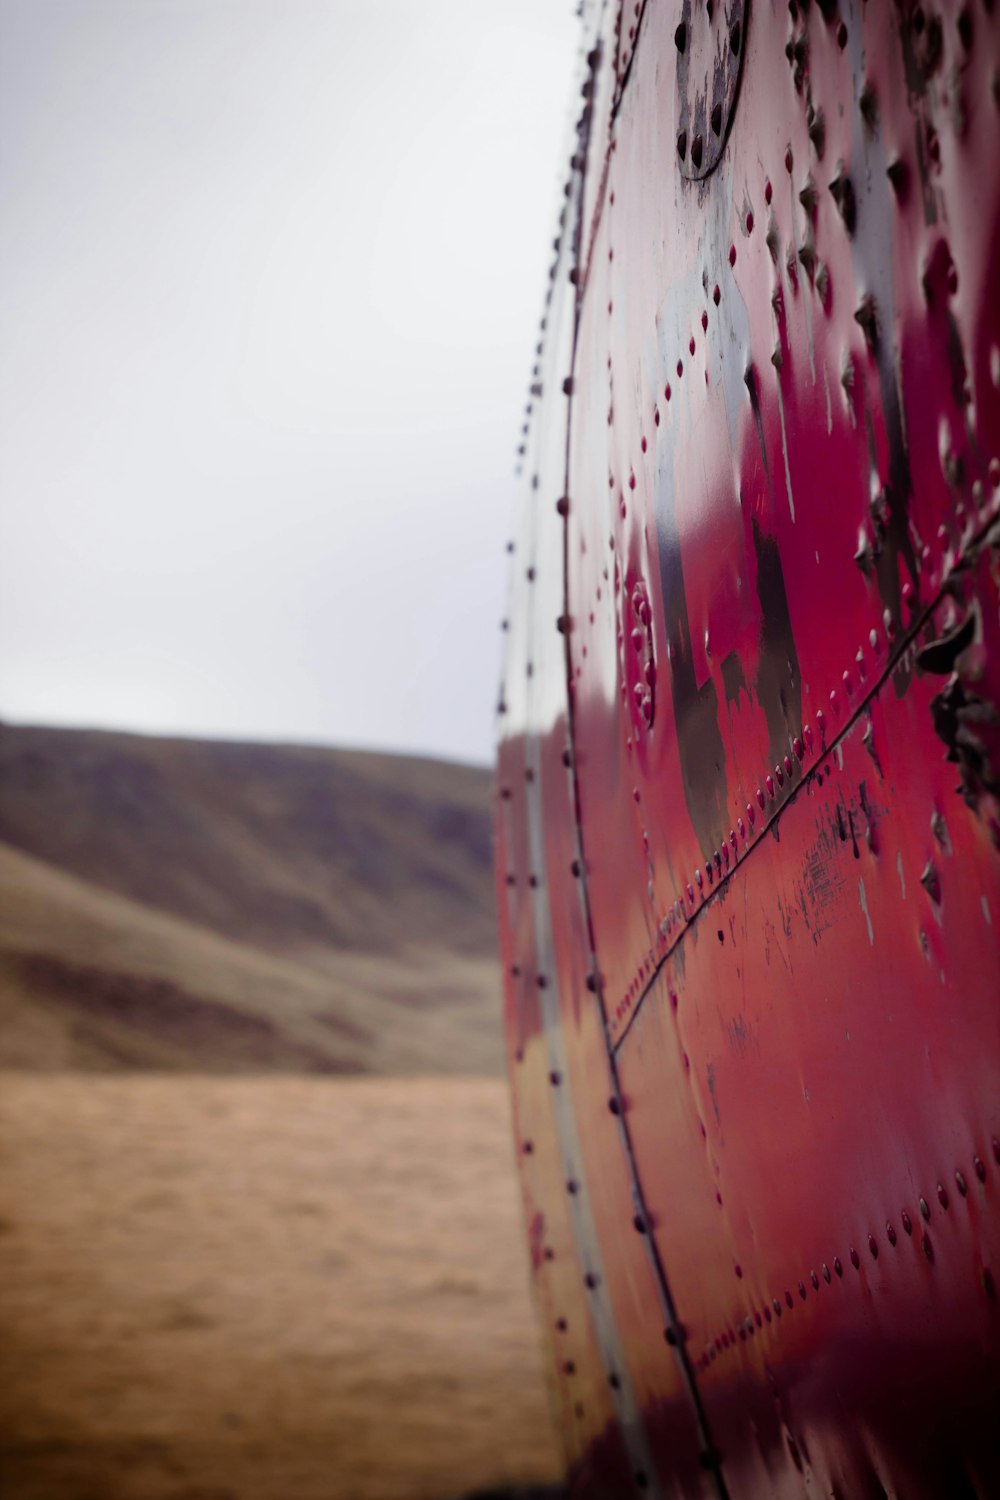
(496, 0), (1000, 1497)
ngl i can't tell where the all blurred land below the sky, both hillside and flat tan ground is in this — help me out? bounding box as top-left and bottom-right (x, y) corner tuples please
(0, 726), (559, 1500)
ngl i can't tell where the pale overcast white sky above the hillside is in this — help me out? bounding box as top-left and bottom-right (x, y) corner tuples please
(0, 0), (580, 762)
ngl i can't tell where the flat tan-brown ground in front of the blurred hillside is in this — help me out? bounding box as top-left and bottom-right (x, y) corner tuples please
(0, 1074), (561, 1500)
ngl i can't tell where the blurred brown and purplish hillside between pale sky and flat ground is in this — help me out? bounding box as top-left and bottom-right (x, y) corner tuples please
(0, 726), (502, 1074)
